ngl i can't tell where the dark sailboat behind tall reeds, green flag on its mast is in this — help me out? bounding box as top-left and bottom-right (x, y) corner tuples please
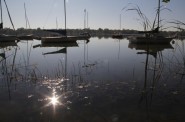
(129, 0), (173, 44)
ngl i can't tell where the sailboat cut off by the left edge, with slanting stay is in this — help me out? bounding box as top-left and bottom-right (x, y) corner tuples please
(0, 0), (17, 42)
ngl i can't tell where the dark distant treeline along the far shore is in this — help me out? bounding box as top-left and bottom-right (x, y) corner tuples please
(0, 28), (185, 37)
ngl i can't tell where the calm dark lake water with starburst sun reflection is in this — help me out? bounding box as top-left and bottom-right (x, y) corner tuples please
(0, 38), (185, 122)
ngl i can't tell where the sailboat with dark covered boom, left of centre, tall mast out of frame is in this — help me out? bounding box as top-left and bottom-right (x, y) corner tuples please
(41, 0), (90, 43)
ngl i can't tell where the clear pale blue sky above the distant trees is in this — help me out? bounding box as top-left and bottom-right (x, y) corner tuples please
(2, 0), (185, 30)
